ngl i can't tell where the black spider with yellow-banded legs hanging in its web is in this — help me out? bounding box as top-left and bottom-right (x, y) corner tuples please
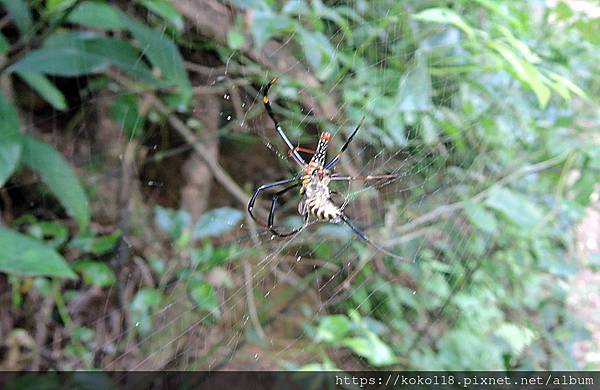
(248, 77), (406, 261)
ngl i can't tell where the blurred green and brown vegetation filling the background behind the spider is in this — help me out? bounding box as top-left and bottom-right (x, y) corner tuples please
(0, 0), (600, 370)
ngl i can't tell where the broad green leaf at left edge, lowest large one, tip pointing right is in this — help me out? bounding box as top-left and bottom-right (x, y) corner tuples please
(0, 228), (77, 279)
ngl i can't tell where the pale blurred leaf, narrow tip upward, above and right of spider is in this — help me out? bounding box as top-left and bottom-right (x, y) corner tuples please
(394, 52), (432, 111)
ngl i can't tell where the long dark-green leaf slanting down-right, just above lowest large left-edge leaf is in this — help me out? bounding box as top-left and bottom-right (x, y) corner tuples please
(23, 135), (90, 230)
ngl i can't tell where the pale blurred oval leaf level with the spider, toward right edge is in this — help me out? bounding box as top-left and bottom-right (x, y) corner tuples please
(486, 188), (543, 230)
